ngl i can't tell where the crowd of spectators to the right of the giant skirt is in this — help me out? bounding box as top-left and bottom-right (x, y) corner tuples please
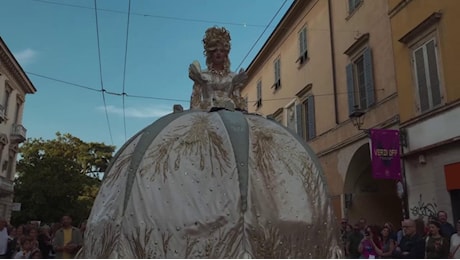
(341, 211), (460, 259)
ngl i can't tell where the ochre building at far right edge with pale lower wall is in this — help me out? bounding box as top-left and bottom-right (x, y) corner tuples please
(388, 0), (460, 223)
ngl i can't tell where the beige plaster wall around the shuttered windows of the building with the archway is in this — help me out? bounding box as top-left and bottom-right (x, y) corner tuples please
(242, 0), (400, 224)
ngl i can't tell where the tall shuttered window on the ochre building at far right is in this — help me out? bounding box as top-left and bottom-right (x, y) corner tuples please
(412, 38), (442, 112)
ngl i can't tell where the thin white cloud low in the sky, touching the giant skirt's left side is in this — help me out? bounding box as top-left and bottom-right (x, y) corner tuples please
(98, 106), (173, 118)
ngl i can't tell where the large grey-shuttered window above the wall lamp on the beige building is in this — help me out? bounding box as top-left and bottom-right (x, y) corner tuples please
(346, 48), (375, 114)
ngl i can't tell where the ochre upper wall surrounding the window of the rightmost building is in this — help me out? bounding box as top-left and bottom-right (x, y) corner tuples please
(389, 0), (460, 123)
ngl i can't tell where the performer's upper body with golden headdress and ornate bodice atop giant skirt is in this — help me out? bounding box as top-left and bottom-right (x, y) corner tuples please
(189, 27), (247, 110)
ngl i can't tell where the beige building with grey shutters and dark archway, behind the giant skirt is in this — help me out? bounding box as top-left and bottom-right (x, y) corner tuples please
(242, 0), (402, 224)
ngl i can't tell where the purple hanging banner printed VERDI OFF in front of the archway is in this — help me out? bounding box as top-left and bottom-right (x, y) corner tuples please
(370, 129), (401, 180)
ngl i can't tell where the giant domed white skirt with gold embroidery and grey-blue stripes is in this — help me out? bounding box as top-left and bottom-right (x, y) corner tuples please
(80, 110), (340, 258)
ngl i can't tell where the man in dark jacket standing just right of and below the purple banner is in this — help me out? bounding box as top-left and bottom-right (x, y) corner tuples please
(393, 219), (425, 259)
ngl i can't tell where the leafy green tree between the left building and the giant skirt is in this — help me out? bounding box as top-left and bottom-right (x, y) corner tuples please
(12, 132), (115, 224)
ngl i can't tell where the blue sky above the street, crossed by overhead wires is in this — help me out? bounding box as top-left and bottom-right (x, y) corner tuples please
(0, 0), (293, 149)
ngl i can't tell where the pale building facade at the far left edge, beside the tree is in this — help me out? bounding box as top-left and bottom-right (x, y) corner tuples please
(0, 37), (37, 219)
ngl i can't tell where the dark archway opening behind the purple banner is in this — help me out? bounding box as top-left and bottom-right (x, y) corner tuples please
(344, 143), (403, 227)
